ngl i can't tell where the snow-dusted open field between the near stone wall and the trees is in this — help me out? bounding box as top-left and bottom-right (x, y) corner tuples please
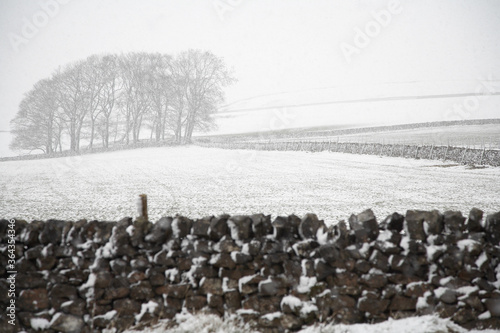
(0, 146), (500, 224)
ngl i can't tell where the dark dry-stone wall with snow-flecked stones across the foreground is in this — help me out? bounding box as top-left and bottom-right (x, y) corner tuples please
(0, 209), (500, 332)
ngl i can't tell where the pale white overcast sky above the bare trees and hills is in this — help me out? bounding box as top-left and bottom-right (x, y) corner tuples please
(0, 0), (500, 156)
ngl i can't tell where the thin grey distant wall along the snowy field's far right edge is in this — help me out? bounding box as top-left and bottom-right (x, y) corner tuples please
(196, 141), (500, 167)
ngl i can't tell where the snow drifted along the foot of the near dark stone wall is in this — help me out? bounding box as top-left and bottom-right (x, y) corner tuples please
(120, 314), (498, 333)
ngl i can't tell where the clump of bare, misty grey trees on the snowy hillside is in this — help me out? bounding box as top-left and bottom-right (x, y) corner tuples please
(11, 50), (235, 154)
